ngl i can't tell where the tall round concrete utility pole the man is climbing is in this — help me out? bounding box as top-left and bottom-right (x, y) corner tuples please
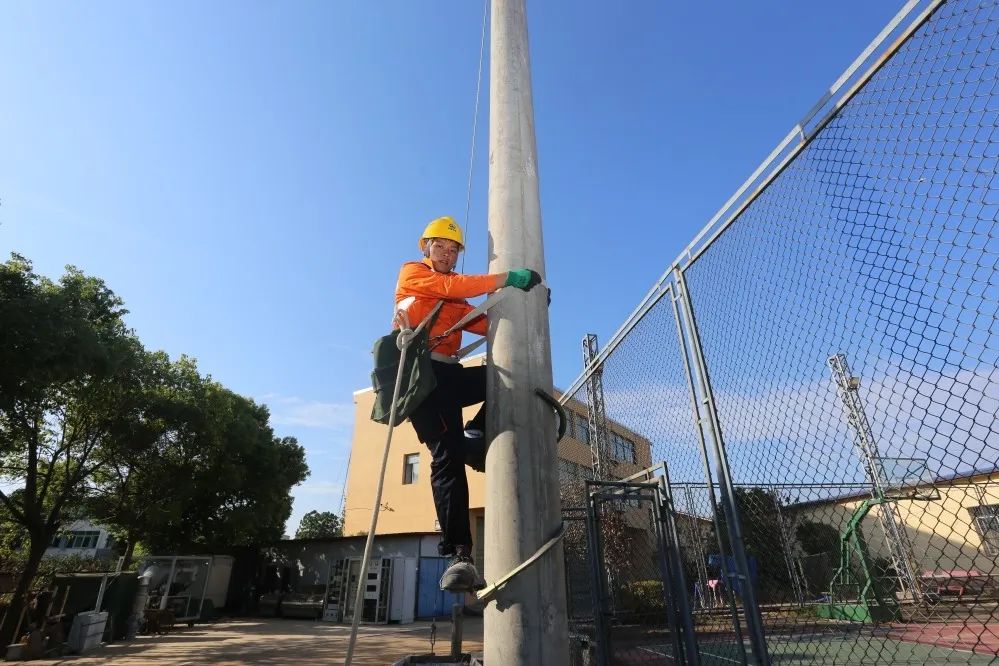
(484, 0), (569, 666)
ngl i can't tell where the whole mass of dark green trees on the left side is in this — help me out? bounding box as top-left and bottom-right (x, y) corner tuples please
(0, 254), (308, 645)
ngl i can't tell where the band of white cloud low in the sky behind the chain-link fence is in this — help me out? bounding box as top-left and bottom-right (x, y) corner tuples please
(584, 362), (999, 490)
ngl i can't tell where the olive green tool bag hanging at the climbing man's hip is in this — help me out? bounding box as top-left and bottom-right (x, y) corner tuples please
(371, 301), (443, 426)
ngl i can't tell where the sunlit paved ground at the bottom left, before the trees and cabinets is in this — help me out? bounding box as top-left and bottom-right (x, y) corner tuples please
(24, 618), (482, 666)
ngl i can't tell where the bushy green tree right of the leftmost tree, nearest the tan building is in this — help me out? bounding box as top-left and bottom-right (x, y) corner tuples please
(90, 358), (309, 553)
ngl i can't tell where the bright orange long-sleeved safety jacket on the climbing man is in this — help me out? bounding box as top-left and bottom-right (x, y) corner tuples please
(395, 259), (507, 356)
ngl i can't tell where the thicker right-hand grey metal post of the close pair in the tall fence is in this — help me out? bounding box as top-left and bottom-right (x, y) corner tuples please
(676, 268), (770, 666)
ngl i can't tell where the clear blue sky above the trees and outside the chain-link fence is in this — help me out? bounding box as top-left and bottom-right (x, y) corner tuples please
(0, 0), (902, 533)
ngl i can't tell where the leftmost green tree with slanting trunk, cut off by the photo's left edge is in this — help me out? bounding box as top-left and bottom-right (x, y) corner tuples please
(0, 255), (154, 645)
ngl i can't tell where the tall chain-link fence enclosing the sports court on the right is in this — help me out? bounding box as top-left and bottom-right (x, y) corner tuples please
(560, 0), (999, 664)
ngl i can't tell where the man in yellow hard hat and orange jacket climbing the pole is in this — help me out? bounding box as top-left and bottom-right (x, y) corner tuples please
(394, 217), (541, 592)
